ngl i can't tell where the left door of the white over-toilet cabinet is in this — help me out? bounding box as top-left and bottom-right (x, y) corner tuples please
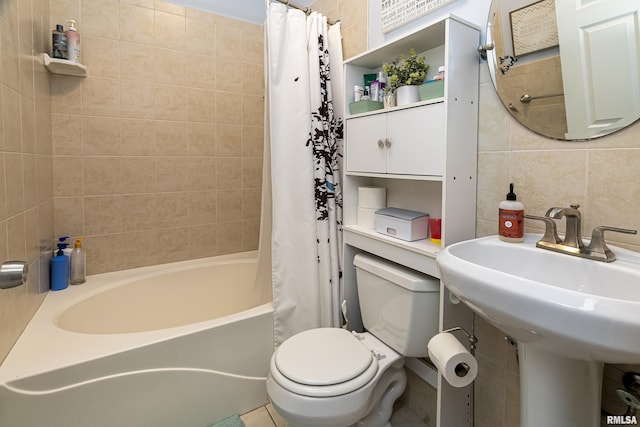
(345, 114), (387, 173)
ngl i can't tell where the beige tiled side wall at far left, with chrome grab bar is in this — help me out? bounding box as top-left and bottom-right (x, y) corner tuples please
(0, 0), (53, 361)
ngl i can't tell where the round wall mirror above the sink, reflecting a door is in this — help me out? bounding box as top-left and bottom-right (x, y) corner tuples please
(487, 0), (640, 140)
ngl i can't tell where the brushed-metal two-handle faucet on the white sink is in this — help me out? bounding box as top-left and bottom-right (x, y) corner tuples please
(525, 205), (638, 262)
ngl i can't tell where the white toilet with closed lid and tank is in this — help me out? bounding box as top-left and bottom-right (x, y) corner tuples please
(267, 254), (440, 427)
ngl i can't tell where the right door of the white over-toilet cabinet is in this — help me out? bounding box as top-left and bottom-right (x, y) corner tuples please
(387, 103), (444, 176)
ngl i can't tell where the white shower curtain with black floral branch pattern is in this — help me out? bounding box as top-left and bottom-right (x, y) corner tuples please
(260, 2), (344, 346)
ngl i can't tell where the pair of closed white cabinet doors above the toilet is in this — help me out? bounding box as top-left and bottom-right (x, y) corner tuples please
(345, 102), (444, 176)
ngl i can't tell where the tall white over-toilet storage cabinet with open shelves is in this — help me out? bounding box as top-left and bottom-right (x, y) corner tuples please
(343, 15), (480, 427)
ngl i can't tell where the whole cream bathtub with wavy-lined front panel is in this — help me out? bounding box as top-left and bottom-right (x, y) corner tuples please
(0, 252), (273, 427)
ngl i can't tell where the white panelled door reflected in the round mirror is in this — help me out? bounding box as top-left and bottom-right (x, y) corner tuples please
(556, 0), (640, 139)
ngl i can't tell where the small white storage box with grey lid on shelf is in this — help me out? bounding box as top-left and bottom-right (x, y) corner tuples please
(376, 208), (429, 242)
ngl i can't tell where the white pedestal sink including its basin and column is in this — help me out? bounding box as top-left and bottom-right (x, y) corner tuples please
(436, 234), (640, 427)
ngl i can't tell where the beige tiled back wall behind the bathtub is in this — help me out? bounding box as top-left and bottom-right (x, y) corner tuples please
(50, 0), (264, 274)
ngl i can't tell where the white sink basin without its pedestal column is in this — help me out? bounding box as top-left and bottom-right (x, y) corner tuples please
(436, 234), (640, 363)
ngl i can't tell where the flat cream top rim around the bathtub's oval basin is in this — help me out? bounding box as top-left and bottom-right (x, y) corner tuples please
(0, 251), (273, 384)
